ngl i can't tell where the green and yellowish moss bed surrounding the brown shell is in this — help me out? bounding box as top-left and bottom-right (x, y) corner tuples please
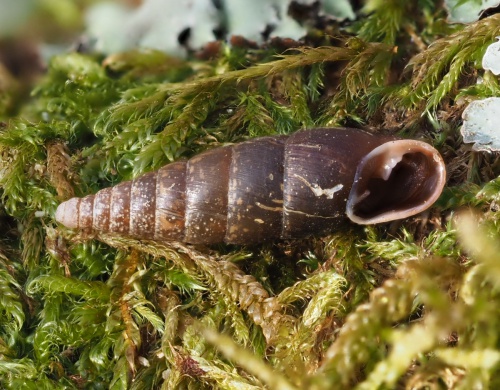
(0, 0), (500, 390)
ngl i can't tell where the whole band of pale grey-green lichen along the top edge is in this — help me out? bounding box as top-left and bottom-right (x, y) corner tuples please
(88, 0), (355, 56)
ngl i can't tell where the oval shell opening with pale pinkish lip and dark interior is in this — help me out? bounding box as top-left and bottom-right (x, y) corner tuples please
(346, 140), (446, 224)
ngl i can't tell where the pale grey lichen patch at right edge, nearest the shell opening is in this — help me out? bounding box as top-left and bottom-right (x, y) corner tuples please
(460, 97), (500, 151)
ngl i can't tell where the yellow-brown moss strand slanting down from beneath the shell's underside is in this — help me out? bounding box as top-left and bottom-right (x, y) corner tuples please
(99, 234), (296, 345)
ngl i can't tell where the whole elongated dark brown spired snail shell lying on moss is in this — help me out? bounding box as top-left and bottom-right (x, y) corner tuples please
(56, 128), (446, 244)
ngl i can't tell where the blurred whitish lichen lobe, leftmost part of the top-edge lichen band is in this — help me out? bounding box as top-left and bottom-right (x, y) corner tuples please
(87, 0), (221, 56)
